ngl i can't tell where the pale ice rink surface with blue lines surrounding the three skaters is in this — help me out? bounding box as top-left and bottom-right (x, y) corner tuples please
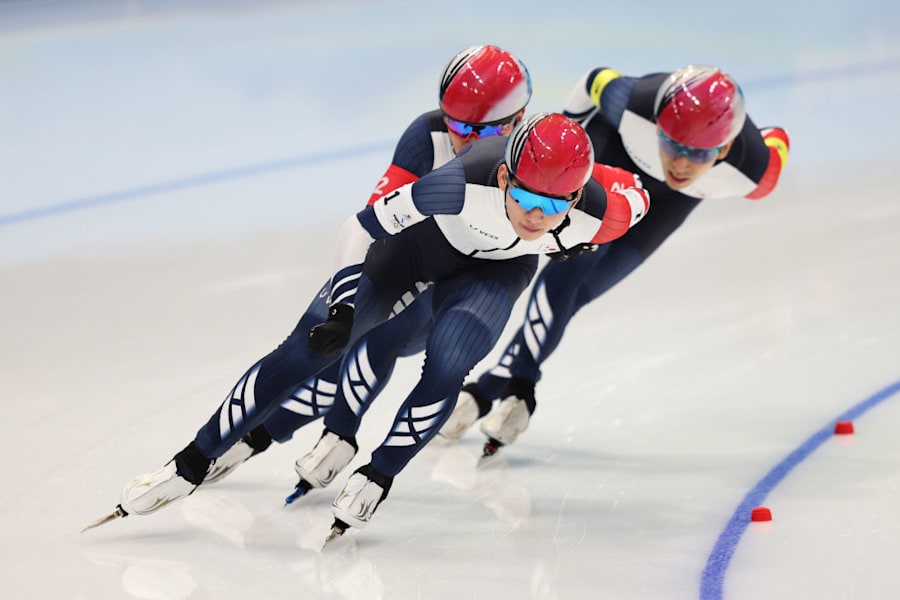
(0, 0), (900, 600)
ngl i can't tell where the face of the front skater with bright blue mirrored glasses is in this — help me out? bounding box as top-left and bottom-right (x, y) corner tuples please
(497, 165), (581, 242)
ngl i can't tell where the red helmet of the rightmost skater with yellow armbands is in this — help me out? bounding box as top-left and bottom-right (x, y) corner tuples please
(653, 65), (747, 148)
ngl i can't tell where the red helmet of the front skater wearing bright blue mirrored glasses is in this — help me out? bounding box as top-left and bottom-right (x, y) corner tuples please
(505, 113), (594, 196)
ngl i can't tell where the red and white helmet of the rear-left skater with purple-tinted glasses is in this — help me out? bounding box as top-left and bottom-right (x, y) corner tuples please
(439, 46), (531, 123)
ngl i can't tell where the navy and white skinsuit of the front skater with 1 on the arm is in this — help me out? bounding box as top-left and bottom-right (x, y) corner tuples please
(189, 138), (624, 477)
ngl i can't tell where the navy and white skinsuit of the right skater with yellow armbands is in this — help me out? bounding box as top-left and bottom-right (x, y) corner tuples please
(477, 69), (770, 411)
